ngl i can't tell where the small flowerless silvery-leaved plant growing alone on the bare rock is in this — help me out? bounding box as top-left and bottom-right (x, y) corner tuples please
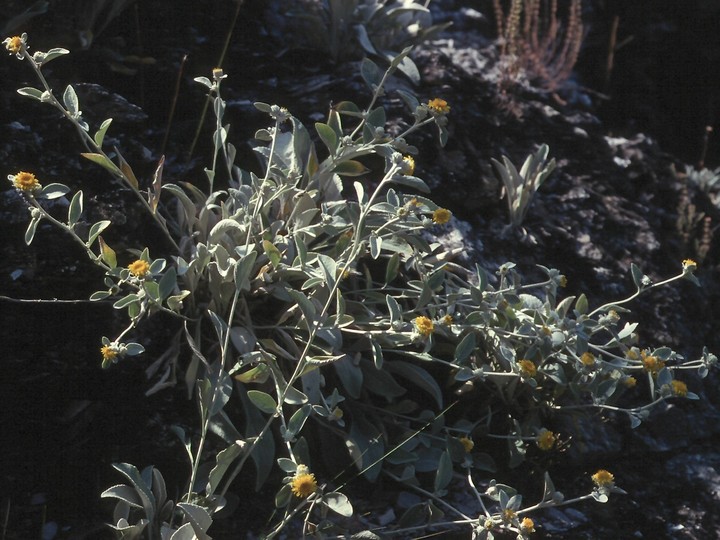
(492, 144), (555, 232)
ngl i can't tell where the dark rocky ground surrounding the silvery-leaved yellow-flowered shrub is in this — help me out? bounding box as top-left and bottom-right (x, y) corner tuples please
(0, 0), (720, 540)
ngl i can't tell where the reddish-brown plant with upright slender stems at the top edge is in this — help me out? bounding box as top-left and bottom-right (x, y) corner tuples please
(493, 0), (584, 99)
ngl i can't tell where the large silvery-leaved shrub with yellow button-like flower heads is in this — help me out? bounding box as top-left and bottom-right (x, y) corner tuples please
(4, 34), (717, 539)
